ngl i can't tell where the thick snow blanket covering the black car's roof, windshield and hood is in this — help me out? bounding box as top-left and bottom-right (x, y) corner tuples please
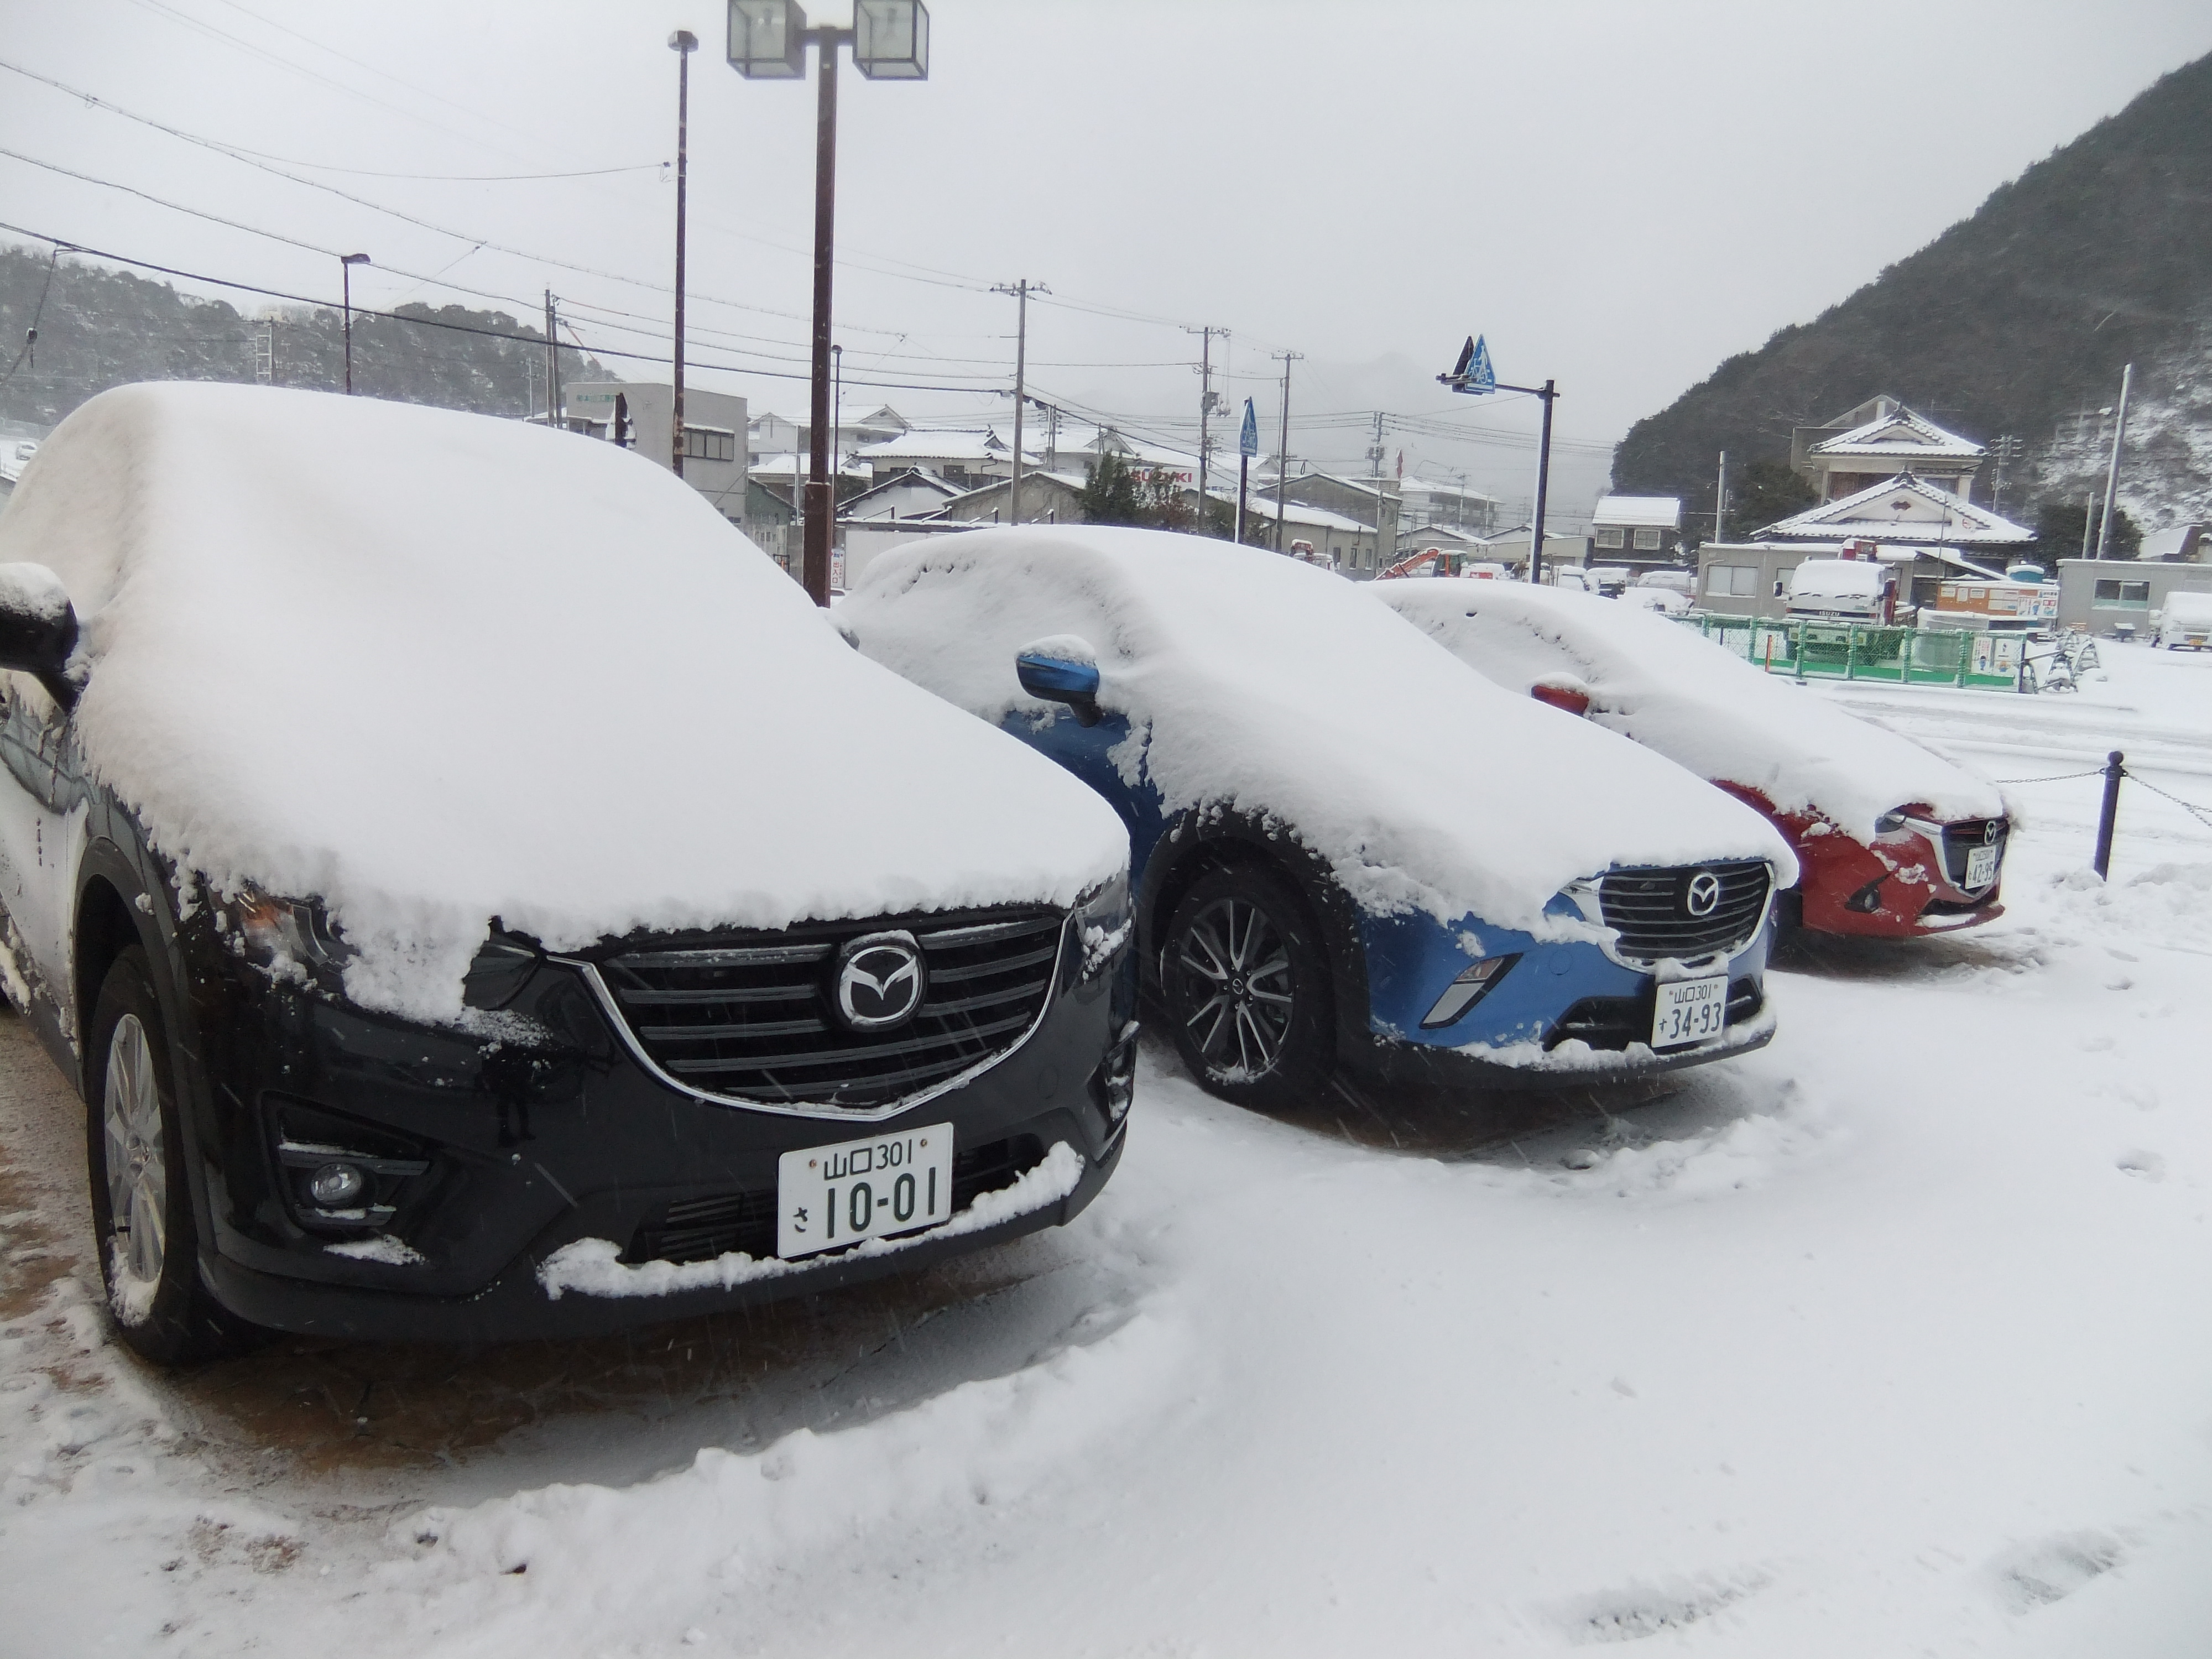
(0, 383), (1128, 1018)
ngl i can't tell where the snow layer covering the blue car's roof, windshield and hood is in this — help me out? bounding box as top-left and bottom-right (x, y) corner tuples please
(838, 526), (1796, 936)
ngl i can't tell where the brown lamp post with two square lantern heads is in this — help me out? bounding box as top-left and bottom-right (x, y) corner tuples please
(730, 0), (929, 606)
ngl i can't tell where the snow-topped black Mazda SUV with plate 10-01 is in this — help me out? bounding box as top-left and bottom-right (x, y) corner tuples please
(0, 383), (1135, 1360)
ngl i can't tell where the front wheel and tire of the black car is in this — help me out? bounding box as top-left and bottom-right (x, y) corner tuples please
(84, 945), (257, 1365)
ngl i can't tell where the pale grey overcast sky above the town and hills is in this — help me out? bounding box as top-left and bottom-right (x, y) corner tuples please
(0, 0), (2212, 518)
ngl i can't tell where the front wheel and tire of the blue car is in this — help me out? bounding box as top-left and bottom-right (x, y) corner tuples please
(1159, 865), (1336, 1110)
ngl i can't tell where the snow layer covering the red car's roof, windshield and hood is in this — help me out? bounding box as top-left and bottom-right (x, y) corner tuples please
(1374, 582), (2004, 841)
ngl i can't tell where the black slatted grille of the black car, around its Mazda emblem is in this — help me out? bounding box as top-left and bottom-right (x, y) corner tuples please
(599, 909), (1062, 1108)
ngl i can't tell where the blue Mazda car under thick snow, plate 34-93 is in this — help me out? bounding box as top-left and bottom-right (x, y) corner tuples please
(836, 526), (1796, 1108)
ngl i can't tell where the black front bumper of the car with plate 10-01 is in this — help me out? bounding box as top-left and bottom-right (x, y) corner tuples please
(190, 947), (1130, 1340)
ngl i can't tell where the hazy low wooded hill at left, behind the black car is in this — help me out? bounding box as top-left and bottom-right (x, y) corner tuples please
(0, 246), (608, 427)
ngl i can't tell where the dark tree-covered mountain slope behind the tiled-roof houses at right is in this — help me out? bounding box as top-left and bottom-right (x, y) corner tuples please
(1613, 58), (2212, 546)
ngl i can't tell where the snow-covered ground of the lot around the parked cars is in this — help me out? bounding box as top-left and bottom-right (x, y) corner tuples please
(13, 646), (2212, 1659)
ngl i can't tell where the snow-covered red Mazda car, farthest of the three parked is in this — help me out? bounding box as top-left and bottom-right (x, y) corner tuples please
(1363, 582), (2011, 938)
